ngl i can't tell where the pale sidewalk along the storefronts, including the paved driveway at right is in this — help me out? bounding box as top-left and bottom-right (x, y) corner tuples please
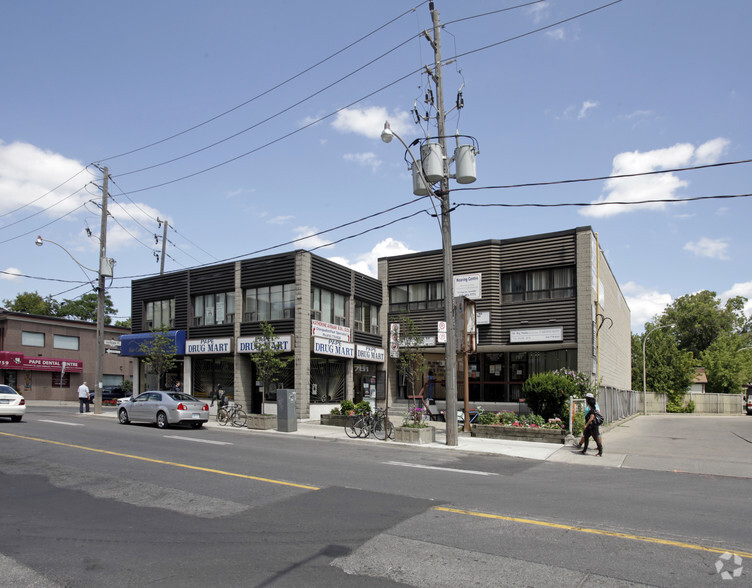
(32, 403), (752, 478)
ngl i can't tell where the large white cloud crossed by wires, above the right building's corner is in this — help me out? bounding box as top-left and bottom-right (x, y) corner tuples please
(580, 138), (728, 218)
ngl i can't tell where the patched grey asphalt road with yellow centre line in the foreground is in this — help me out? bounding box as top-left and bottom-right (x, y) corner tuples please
(0, 408), (752, 587)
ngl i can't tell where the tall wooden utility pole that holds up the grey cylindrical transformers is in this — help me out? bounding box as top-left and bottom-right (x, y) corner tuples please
(428, 1), (458, 446)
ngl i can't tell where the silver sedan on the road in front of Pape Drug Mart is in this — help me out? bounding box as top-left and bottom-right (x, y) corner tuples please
(118, 391), (209, 429)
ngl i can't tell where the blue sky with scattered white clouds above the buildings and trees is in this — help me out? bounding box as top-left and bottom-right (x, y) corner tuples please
(0, 0), (752, 333)
